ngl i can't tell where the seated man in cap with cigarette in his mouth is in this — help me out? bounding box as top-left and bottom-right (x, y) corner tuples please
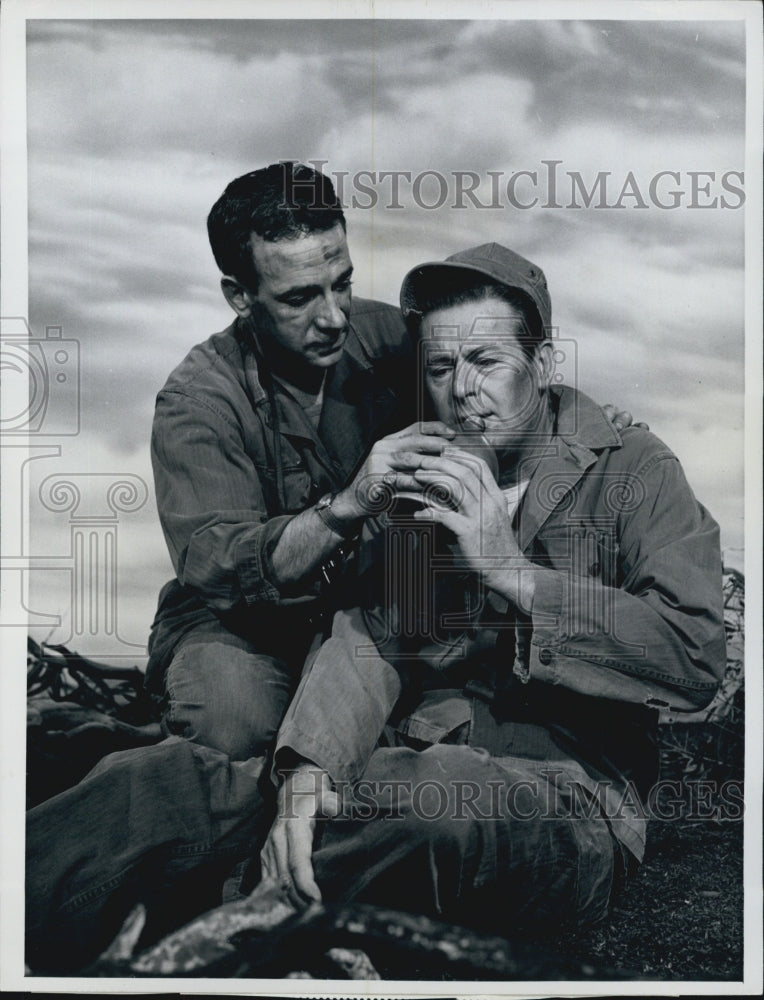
(262, 244), (725, 934)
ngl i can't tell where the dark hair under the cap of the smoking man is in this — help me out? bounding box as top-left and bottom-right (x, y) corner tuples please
(408, 268), (546, 357)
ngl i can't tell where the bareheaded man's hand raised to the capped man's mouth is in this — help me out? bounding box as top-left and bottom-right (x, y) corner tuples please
(332, 420), (456, 522)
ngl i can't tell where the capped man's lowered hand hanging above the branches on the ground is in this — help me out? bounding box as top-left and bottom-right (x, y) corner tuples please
(260, 762), (341, 909)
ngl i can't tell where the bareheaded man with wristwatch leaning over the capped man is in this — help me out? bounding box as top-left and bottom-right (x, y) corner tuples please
(146, 162), (640, 760)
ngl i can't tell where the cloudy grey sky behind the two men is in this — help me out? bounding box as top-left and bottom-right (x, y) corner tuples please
(20, 13), (745, 662)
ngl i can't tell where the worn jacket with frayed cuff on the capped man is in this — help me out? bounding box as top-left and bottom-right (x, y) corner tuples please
(276, 388), (725, 857)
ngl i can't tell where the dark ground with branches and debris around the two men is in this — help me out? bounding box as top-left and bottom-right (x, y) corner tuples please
(27, 570), (745, 981)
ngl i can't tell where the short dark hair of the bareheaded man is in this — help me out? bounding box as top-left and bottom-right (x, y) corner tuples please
(207, 160), (345, 291)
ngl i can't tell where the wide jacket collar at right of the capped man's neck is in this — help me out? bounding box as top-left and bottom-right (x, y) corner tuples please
(518, 386), (623, 552)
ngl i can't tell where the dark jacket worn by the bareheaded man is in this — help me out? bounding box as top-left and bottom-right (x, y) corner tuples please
(147, 299), (416, 690)
